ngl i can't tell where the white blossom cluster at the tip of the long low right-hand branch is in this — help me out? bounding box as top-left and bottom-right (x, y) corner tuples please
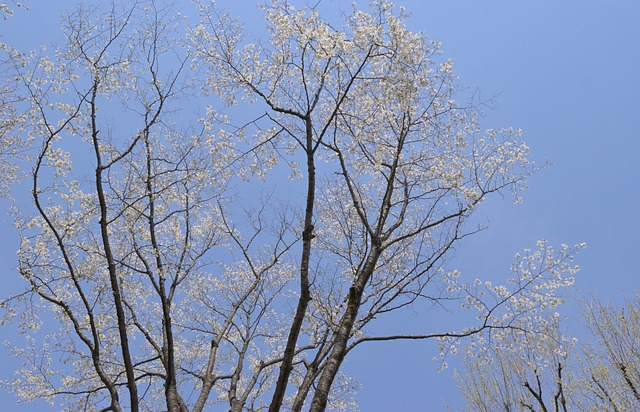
(441, 240), (586, 366)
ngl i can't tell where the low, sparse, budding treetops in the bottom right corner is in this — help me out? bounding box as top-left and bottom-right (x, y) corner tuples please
(459, 295), (640, 411)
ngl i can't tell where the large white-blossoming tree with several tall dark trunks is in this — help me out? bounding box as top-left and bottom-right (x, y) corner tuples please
(4, 1), (577, 411)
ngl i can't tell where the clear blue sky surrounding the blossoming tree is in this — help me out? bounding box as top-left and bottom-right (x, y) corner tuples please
(0, 0), (640, 411)
